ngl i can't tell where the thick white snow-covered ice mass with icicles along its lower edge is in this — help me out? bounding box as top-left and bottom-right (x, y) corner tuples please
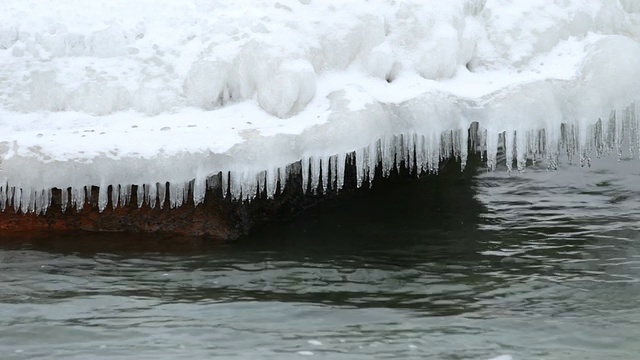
(0, 0), (640, 212)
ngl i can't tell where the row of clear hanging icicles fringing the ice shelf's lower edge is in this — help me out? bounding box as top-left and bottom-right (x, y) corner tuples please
(0, 103), (640, 213)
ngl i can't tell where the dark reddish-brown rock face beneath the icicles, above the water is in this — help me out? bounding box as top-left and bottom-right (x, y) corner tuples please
(0, 156), (470, 241)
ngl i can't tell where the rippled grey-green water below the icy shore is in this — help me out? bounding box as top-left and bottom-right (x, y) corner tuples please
(0, 161), (640, 360)
